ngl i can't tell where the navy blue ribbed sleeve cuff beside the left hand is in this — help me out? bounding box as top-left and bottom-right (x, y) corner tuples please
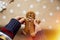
(5, 19), (21, 34)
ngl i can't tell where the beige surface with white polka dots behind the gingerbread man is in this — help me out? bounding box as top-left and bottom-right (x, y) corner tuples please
(0, 0), (60, 29)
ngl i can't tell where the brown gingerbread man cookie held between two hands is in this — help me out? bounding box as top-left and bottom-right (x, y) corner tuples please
(23, 11), (40, 36)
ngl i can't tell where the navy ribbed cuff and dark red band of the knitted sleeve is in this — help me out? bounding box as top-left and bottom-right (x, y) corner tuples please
(1, 19), (21, 38)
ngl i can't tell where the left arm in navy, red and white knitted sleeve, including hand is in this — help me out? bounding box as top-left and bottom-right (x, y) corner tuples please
(0, 17), (24, 40)
